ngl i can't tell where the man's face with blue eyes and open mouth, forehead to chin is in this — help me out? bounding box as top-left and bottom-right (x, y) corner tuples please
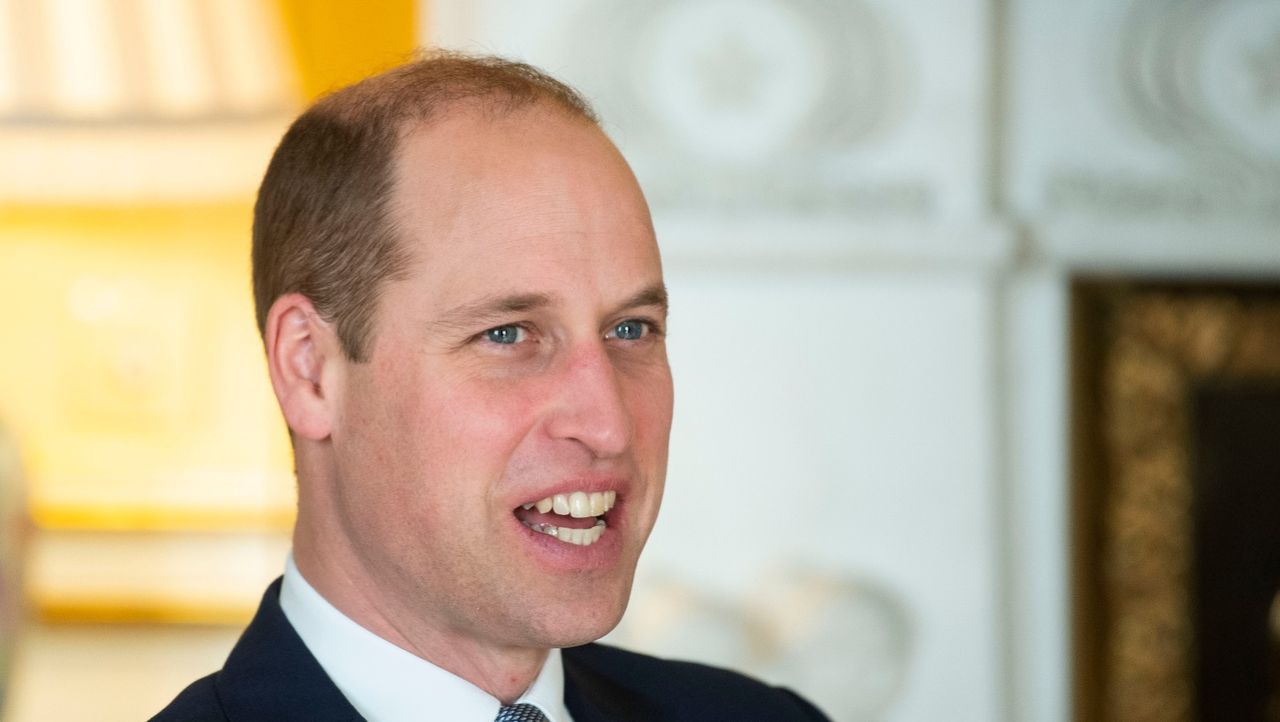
(332, 108), (672, 648)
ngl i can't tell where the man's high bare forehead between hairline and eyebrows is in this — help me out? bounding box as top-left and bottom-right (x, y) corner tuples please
(392, 105), (660, 299)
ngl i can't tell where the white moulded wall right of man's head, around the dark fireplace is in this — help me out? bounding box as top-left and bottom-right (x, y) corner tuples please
(425, 0), (1280, 722)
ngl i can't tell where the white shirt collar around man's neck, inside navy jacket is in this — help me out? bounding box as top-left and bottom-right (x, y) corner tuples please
(280, 554), (572, 722)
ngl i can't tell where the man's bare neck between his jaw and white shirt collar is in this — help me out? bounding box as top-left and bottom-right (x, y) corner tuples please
(293, 518), (549, 704)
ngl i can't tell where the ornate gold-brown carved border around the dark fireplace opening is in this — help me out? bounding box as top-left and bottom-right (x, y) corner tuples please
(1096, 291), (1280, 722)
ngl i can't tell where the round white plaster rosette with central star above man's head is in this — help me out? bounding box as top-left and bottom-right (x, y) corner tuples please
(575, 0), (904, 164)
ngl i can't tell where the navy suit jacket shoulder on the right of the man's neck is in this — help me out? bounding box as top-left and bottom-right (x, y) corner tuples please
(562, 644), (827, 721)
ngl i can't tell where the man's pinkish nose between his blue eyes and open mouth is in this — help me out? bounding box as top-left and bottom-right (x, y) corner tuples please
(547, 342), (634, 458)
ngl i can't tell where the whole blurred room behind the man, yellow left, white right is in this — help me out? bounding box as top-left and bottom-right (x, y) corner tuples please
(0, 0), (1280, 722)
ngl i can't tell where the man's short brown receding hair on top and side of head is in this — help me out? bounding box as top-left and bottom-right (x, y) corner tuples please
(252, 51), (599, 361)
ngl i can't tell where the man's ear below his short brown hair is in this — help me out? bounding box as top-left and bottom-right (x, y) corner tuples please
(266, 293), (346, 440)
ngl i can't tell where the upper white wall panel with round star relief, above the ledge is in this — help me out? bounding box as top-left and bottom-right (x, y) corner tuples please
(430, 0), (1004, 255)
